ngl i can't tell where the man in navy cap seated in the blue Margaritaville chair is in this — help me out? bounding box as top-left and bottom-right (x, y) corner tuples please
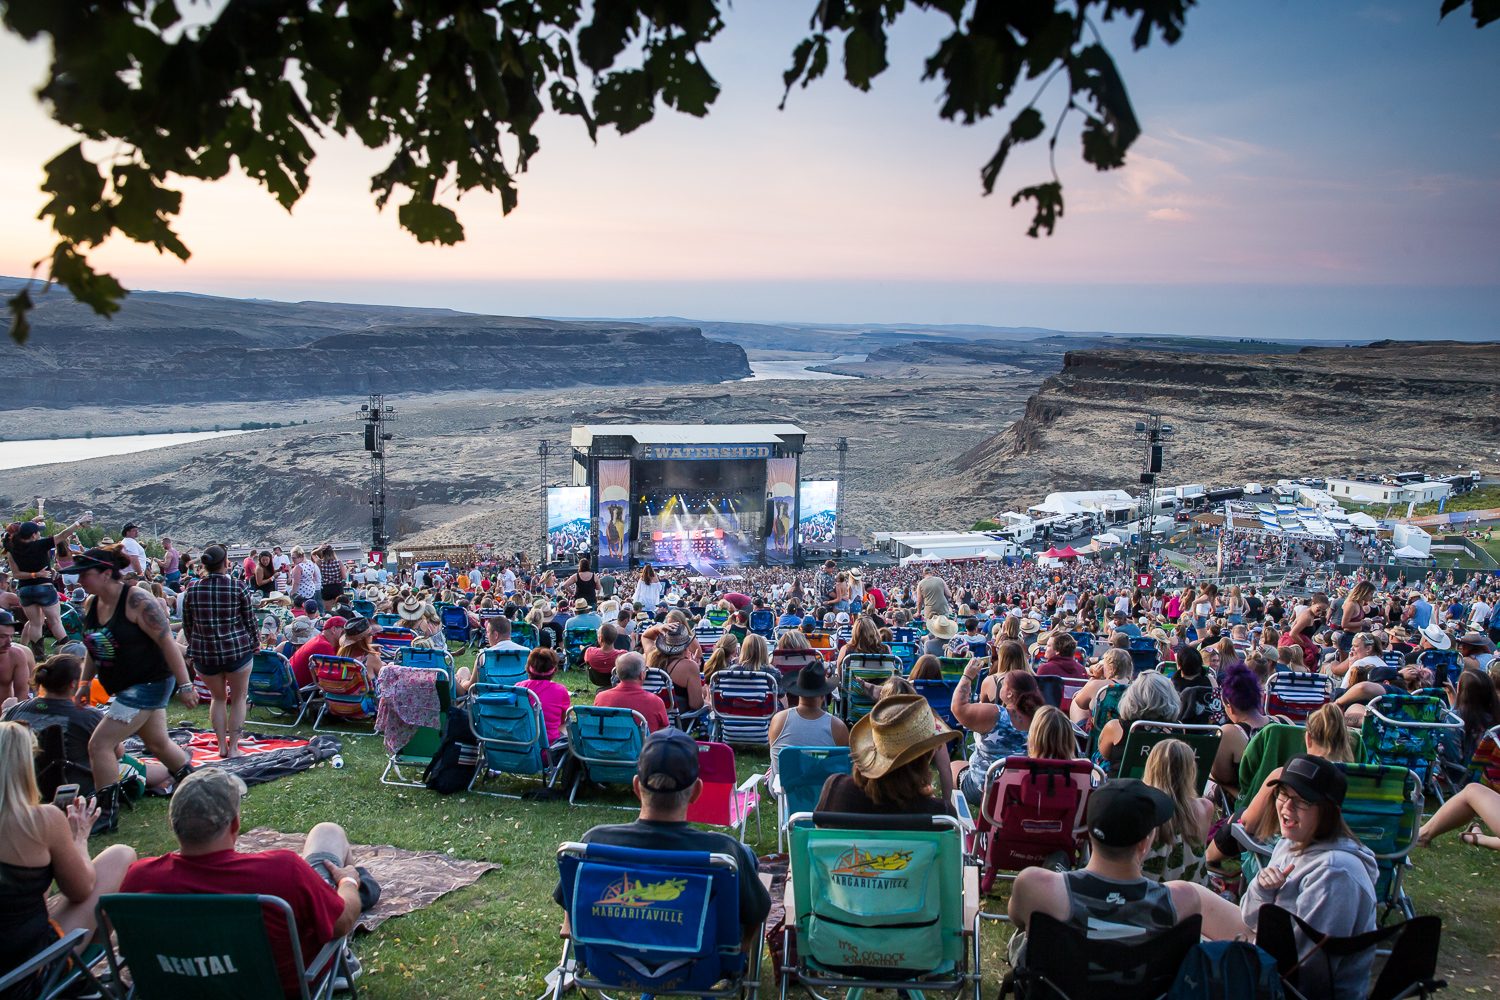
(552, 729), (771, 951)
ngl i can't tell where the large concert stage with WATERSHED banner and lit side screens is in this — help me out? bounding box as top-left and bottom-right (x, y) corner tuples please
(564, 424), (837, 571)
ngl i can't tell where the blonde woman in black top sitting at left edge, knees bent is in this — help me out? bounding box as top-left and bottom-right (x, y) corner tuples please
(0, 723), (135, 997)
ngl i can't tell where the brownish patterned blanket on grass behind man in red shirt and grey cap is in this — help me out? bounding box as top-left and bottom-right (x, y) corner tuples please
(234, 826), (500, 931)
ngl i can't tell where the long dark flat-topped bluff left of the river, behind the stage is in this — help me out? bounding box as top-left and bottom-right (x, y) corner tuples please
(0, 281), (752, 409)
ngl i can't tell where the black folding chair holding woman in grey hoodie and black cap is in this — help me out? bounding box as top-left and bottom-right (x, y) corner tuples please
(1256, 903), (1448, 1000)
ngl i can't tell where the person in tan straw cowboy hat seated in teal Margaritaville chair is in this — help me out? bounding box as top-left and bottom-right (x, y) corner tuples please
(816, 694), (962, 816)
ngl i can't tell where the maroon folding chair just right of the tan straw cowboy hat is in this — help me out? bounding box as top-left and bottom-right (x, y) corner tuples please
(971, 757), (1104, 894)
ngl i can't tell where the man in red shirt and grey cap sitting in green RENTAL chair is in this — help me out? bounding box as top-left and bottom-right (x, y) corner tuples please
(120, 768), (360, 996)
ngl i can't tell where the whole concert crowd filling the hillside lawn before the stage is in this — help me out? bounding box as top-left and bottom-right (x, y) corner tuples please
(0, 519), (1500, 1000)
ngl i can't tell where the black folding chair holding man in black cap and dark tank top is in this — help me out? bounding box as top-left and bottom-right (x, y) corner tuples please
(996, 912), (1203, 1000)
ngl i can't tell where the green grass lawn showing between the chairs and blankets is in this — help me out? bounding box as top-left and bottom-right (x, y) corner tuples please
(90, 658), (1500, 1000)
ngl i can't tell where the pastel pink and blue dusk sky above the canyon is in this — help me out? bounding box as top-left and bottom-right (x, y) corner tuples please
(0, 0), (1500, 339)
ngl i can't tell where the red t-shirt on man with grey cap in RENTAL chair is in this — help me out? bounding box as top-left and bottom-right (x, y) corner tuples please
(120, 850), (344, 996)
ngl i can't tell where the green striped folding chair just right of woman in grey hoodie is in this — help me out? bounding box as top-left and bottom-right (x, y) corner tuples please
(1338, 763), (1422, 922)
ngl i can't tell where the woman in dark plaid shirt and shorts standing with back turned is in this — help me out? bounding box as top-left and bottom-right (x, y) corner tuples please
(183, 544), (257, 759)
